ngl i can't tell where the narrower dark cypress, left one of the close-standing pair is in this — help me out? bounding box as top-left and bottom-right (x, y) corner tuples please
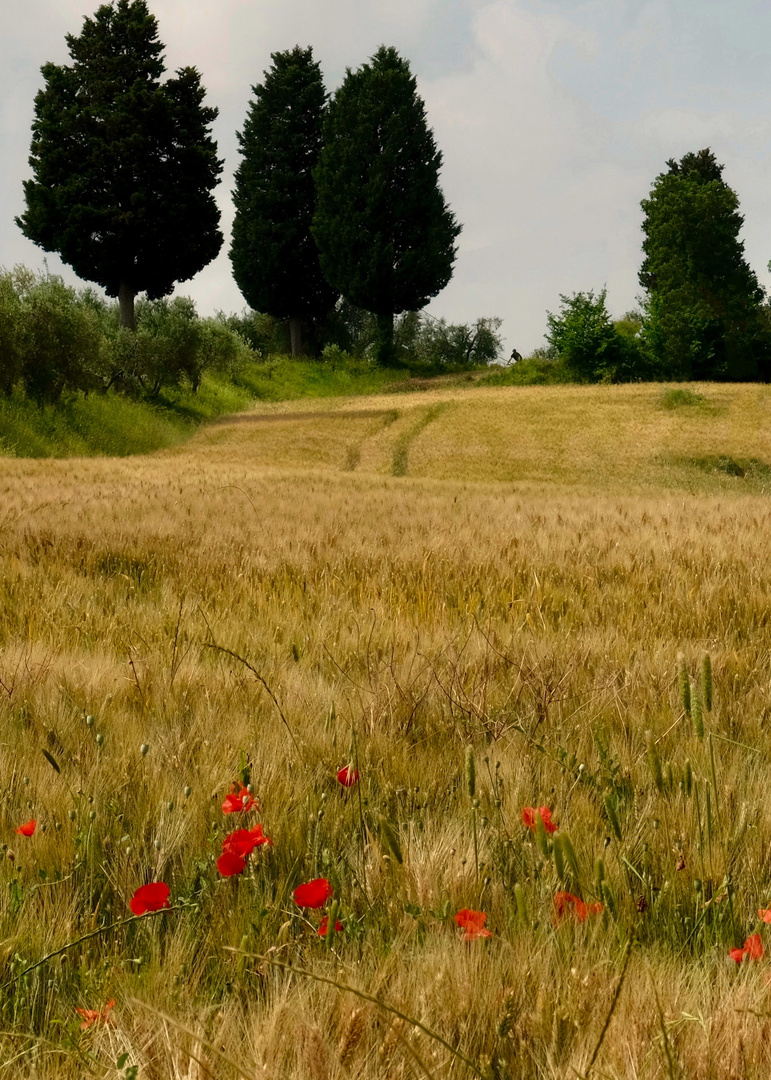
(230, 45), (338, 353)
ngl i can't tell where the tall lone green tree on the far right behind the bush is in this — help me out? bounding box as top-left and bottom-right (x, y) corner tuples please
(639, 149), (765, 379)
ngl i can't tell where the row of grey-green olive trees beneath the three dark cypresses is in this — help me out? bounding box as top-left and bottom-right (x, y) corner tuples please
(0, 267), (500, 402)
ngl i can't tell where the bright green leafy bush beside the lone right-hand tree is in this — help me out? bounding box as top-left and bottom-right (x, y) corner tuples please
(546, 288), (651, 382)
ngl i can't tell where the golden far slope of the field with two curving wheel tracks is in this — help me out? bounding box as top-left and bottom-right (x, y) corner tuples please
(187, 383), (771, 491)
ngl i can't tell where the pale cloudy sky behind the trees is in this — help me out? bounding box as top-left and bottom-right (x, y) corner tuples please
(0, 0), (771, 353)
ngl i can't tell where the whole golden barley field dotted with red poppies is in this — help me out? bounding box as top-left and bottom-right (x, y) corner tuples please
(0, 386), (771, 1080)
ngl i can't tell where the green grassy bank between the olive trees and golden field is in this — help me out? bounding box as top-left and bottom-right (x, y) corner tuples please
(0, 356), (408, 458)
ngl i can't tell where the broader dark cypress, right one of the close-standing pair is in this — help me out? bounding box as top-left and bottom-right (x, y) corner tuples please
(313, 46), (460, 363)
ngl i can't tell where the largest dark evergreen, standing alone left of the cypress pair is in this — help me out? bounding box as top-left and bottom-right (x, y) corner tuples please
(17, 0), (222, 328)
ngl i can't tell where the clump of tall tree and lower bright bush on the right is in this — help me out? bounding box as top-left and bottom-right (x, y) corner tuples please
(539, 149), (771, 382)
